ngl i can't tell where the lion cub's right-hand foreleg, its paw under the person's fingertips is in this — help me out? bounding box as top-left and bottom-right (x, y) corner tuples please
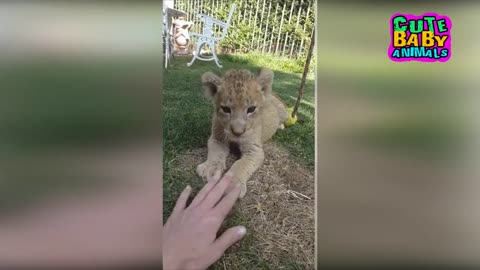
(228, 144), (265, 198)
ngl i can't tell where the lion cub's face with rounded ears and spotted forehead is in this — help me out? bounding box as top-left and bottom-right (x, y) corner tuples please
(202, 69), (273, 137)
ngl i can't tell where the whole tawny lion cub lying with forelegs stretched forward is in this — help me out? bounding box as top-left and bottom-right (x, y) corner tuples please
(197, 68), (288, 197)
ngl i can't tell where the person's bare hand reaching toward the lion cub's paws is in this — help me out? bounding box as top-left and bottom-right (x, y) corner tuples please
(163, 173), (246, 270)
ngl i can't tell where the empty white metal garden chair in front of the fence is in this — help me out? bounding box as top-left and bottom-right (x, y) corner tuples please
(187, 4), (236, 68)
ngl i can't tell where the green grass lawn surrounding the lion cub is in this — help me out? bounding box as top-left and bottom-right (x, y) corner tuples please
(162, 54), (315, 269)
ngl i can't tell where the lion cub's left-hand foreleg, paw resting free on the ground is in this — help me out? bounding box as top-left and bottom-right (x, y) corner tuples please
(197, 136), (230, 181)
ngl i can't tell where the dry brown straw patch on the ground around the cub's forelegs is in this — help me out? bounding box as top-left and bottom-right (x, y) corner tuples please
(174, 143), (315, 269)
